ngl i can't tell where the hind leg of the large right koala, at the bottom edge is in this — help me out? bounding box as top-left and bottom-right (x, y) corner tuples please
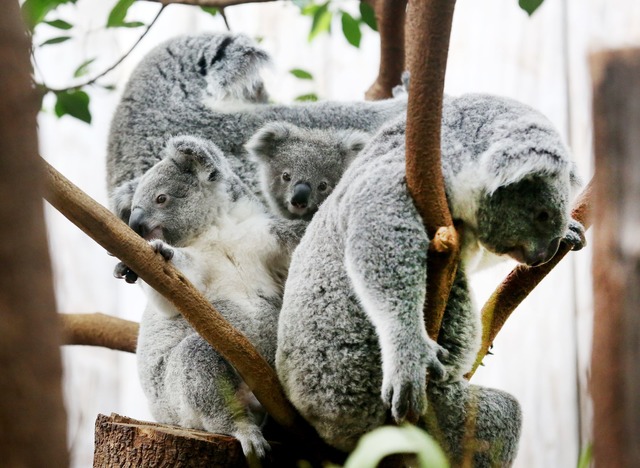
(422, 381), (522, 468)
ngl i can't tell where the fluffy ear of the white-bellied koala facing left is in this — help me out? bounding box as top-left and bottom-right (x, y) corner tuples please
(168, 136), (223, 181)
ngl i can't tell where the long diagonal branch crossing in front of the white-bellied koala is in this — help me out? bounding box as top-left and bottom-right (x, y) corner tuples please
(44, 162), (333, 455)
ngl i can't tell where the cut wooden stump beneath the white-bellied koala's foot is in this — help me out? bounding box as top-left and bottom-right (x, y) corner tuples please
(93, 413), (297, 468)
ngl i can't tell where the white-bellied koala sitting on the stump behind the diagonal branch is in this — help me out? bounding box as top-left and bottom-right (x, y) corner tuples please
(120, 136), (306, 457)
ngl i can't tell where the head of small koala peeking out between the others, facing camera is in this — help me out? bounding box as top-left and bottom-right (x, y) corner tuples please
(245, 122), (369, 221)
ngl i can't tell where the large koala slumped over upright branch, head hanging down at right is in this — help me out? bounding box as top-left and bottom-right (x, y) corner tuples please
(276, 95), (584, 466)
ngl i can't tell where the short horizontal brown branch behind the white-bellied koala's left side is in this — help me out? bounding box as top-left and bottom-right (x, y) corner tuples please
(59, 313), (140, 353)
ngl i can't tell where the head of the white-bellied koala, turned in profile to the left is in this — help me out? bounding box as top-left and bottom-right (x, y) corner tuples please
(129, 136), (239, 246)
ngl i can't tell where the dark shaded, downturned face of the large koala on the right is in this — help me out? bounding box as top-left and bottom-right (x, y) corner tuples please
(477, 175), (570, 266)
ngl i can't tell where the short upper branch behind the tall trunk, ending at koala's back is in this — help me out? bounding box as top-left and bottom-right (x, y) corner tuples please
(364, 0), (407, 101)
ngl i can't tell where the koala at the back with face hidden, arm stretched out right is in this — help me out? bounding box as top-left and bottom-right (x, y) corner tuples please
(107, 34), (406, 221)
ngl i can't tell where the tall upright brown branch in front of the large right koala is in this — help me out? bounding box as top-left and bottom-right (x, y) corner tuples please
(406, 0), (460, 338)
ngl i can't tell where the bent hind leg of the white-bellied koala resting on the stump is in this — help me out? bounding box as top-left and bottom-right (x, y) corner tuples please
(165, 333), (269, 458)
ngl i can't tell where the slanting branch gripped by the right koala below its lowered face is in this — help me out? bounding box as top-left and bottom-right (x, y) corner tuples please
(466, 180), (593, 378)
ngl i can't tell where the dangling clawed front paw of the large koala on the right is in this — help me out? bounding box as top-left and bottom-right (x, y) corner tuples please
(382, 341), (447, 423)
